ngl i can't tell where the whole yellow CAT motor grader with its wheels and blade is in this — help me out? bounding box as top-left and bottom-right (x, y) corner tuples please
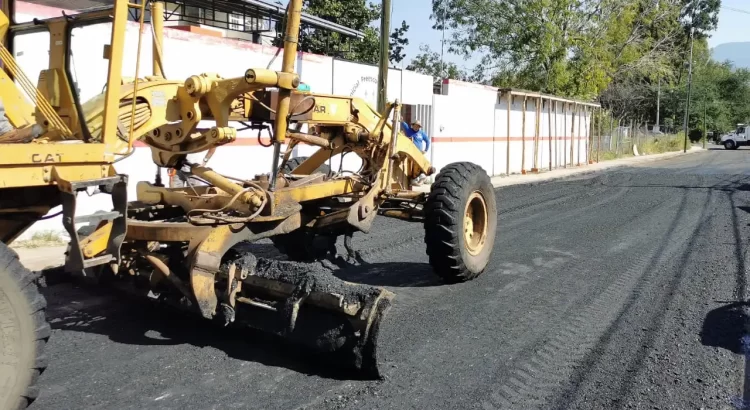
(0, 0), (497, 409)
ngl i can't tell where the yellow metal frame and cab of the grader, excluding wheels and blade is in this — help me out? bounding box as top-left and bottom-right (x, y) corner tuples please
(0, 0), (433, 276)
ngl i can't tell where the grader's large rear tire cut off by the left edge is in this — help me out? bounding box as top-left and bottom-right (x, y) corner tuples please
(0, 243), (51, 409)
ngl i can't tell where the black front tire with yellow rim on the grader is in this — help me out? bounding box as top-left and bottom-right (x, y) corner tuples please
(424, 162), (497, 283)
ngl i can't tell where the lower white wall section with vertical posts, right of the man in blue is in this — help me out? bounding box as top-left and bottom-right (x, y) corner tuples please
(431, 80), (591, 179)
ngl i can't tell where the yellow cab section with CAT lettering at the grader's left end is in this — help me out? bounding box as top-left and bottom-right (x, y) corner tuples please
(0, 0), (141, 193)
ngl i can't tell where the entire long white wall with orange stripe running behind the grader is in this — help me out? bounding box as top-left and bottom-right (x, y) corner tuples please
(14, 3), (600, 237)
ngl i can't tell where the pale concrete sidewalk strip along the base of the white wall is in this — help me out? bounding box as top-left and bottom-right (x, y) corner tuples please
(414, 146), (707, 192)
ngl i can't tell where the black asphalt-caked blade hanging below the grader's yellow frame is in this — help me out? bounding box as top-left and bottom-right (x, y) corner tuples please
(219, 250), (392, 379)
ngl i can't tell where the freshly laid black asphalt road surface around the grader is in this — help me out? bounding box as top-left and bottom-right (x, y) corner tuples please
(32, 149), (750, 410)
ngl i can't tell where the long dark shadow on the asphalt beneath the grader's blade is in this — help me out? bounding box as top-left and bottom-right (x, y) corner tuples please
(43, 284), (382, 380)
